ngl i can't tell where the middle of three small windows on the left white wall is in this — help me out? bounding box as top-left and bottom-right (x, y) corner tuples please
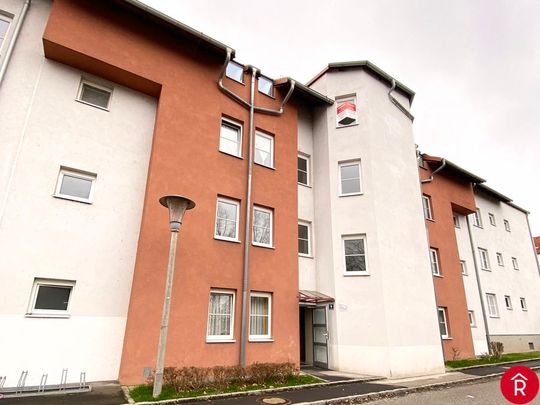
(54, 166), (96, 203)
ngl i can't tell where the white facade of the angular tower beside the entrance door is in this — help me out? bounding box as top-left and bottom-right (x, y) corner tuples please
(298, 69), (444, 377)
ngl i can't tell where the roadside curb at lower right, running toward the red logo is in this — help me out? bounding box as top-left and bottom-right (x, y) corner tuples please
(295, 366), (540, 405)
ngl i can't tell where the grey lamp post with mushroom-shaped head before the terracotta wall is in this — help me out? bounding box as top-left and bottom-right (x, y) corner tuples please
(152, 195), (195, 398)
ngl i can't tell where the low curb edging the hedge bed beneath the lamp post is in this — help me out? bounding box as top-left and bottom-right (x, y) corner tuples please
(122, 377), (385, 405)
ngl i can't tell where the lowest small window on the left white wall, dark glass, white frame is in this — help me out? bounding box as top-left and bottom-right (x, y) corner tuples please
(27, 278), (75, 316)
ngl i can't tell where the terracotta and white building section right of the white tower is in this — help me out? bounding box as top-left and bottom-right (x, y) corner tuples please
(419, 154), (540, 360)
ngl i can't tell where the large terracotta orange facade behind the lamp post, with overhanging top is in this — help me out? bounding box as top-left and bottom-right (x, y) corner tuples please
(44, 0), (299, 384)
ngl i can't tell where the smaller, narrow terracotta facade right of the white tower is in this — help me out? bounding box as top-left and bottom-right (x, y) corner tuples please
(419, 155), (476, 360)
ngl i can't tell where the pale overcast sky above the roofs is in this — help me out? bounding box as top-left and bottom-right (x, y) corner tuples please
(145, 0), (540, 235)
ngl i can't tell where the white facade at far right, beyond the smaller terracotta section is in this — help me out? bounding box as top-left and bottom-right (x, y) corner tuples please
(456, 187), (540, 354)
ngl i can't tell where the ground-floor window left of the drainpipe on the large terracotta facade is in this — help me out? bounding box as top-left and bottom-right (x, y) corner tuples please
(206, 290), (234, 341)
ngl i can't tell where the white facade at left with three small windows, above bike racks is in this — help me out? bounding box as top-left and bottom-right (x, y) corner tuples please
(0, 0), (156, 387)
